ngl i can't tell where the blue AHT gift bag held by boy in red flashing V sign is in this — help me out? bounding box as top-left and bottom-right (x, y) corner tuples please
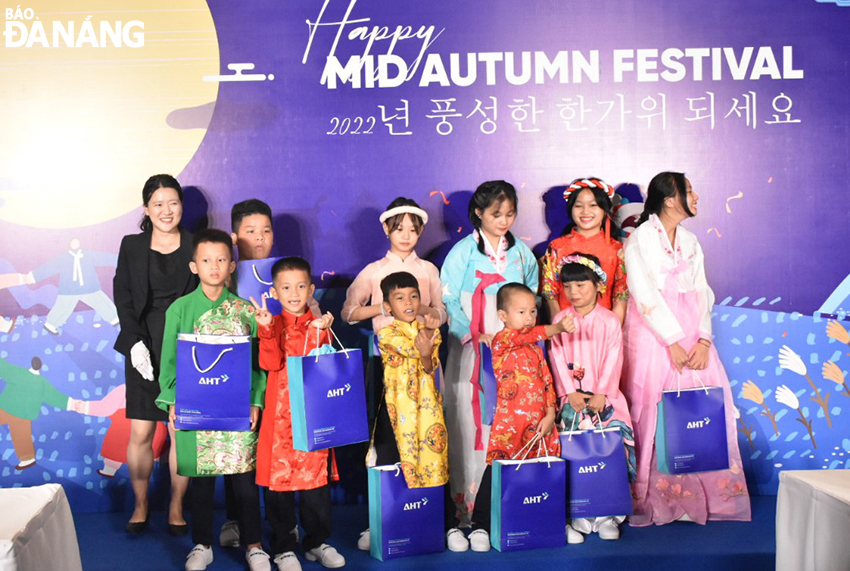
(286, 340), (369, 452)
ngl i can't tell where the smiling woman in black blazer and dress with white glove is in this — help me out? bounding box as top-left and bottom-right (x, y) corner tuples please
(113, 174), (198, 535)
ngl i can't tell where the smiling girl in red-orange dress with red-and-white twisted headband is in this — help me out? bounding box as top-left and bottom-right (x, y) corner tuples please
(541, 177), (629, 323)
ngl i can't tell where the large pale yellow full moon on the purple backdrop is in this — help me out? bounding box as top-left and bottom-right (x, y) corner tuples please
(0, 0), (220, 228)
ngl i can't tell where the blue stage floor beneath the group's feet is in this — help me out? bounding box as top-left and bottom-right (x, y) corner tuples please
(74, 496), (776, 571)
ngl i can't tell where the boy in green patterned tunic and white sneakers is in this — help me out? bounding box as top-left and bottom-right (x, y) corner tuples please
(156, 229), (271, 571)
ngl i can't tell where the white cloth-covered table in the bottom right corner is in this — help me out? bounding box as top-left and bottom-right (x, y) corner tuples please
(776, 470), (850, 571)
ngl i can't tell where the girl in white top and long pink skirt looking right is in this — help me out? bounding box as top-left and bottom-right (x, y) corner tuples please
(623, 172), (750, 526)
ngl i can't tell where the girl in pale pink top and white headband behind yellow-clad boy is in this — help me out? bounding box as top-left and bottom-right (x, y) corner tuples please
(341, 197), (447, 333)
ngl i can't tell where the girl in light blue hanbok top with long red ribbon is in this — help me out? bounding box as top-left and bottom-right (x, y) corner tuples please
(440, 180), (538, 520)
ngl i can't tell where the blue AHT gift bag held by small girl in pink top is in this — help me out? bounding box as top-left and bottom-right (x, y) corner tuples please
(560, 428), (632, 517)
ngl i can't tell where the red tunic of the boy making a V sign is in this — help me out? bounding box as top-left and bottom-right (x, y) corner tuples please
(257, 311), (329, 492)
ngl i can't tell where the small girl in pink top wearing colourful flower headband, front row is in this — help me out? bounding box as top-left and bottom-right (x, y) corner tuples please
(549, 252), (635, 543)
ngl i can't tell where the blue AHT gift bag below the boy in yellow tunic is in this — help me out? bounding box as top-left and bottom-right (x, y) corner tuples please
(368, 464), (446, 561)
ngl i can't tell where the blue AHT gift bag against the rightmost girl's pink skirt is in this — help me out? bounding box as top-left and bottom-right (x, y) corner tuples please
(655, 381), (729, 474)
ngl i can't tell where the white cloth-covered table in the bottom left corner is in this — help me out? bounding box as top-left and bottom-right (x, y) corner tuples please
(0, 484), (83, 571)
